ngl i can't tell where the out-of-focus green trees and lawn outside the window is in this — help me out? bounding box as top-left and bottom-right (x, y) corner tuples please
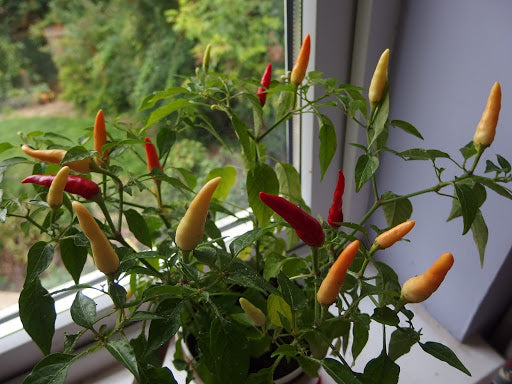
(0, 0), (285, 290)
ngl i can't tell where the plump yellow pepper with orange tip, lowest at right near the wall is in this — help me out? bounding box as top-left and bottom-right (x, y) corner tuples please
(401, 252), (454, 303)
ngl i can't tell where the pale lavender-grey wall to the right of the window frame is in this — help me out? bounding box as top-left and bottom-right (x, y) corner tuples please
(372, 0), (512, 339)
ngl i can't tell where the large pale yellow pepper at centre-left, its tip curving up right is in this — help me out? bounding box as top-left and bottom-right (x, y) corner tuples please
(175, 176), (222, 251)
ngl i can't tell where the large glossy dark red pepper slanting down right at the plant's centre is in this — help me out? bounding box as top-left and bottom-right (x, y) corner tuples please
(260, 192), (325, 247)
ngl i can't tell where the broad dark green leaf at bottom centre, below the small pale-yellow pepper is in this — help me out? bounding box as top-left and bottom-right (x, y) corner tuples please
(209, 318), (250, 384)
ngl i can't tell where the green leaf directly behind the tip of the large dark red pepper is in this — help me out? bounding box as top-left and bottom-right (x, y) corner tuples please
(246, 163), (279, 227)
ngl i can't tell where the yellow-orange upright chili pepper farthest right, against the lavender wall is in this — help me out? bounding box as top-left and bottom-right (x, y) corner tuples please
(473, 82), (501, 150)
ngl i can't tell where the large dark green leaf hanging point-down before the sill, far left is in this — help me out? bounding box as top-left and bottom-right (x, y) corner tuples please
(19, 278), (57, 355)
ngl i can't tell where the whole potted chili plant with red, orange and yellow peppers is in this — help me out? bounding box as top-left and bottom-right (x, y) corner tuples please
(0, 36), (512, 384)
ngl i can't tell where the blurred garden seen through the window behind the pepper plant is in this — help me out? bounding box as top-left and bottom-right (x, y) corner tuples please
(0, 0), (286, 309)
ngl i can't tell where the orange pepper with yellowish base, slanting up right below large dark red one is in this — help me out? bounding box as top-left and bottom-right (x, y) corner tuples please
(316, 240), (360, 305)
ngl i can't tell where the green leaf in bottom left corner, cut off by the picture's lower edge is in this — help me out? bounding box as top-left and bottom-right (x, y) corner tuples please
(23, 353), (75, 384)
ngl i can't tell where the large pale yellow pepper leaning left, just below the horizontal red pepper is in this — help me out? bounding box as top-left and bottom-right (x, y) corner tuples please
(71, 201), (119, 275)
